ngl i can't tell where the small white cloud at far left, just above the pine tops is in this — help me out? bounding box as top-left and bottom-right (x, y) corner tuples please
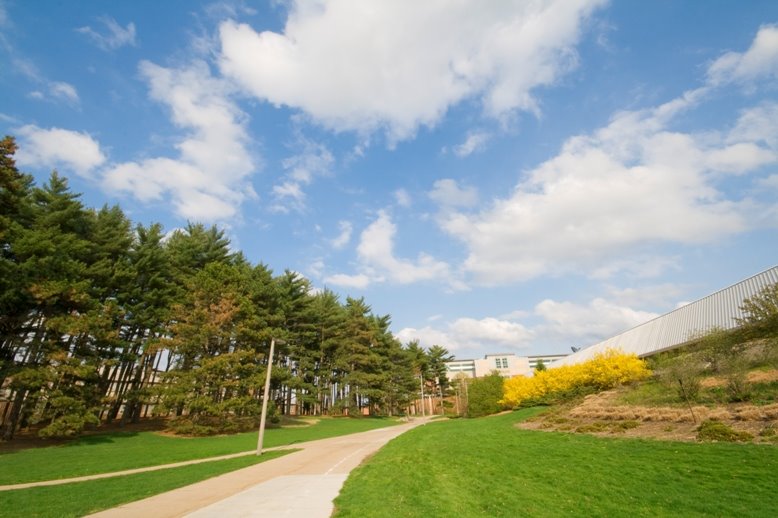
(15, 124), (106, 176)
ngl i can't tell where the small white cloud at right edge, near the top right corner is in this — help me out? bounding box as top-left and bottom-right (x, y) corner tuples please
(708, 25), (778, 86)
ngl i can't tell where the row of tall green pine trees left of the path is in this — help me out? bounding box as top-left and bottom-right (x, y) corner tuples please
(0, 137), (448, 440)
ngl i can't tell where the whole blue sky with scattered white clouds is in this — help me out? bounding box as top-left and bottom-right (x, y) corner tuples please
(0, 0), (778, 359)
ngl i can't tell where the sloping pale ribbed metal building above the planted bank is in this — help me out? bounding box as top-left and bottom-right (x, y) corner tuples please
(552, 266), (778, 367)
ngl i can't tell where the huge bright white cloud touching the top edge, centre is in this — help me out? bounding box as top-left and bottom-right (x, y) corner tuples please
(220, 0), (604, 144)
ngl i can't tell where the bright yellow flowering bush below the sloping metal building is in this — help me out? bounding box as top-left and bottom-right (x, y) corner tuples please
(502, 349), (651, 406)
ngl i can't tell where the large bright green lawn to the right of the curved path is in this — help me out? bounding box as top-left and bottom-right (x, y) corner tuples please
(335, 409), (778, 518)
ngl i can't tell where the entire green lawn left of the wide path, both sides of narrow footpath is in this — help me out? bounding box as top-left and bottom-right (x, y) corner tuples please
(0, 418), (399, 518)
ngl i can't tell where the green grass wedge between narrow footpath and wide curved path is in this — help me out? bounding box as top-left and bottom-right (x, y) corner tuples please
(0, 451), (290, 518)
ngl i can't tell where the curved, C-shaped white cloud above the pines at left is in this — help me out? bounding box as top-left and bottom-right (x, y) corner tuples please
(103, 61), (255, 222)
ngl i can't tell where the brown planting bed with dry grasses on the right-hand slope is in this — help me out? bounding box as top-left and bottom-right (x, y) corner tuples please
(517, 390), (778, 444)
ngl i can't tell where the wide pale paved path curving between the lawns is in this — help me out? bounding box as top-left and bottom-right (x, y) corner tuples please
(91, 418), (428, 518)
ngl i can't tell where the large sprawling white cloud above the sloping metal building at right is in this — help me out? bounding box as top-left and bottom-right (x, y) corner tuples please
(433, 28), (778, 284)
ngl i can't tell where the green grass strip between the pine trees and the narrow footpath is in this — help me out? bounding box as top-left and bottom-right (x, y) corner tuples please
(0, 418), (398, 486)
